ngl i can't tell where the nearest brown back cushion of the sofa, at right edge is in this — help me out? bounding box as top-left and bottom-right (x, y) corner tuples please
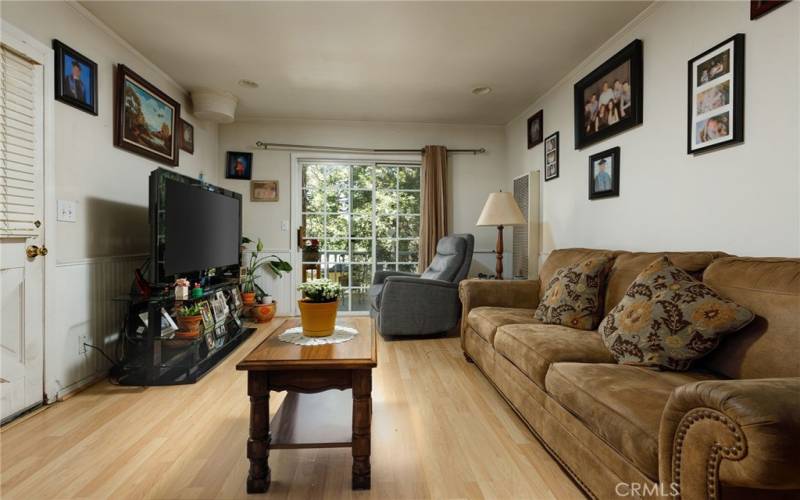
(702, 257), (800, 378)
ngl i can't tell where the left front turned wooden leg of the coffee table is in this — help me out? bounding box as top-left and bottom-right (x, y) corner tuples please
(247, 371), (270, 493)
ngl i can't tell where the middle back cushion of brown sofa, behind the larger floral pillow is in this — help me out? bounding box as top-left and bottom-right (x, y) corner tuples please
(605, 252), (726, 314)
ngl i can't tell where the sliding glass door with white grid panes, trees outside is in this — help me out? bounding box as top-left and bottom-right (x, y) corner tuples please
(298, 161), (420, 311)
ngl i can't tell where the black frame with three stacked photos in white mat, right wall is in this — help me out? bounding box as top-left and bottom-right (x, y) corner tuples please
(686, 33), (745, 154)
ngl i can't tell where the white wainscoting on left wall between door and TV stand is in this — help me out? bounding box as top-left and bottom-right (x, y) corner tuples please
(45, 255), (146, 401)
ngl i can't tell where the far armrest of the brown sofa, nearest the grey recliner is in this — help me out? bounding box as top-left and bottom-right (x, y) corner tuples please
(458, 279), (539, 343)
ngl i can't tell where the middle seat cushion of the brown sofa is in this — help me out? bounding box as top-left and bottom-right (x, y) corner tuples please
(494, 324), (614, 388)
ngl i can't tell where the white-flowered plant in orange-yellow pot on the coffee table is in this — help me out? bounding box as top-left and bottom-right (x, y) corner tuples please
(297, 279), (342, 337)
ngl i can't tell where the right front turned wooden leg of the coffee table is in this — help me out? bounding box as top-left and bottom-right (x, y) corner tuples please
(353, 370), (372, 490)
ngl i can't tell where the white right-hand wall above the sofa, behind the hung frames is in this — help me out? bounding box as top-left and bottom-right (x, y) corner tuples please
(506, 2), (800, 256)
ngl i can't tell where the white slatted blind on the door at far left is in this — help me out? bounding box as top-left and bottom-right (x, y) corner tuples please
(0, 45), (42, 237)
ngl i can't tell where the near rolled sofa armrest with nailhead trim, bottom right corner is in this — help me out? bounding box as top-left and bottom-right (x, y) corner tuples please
(658, 378), (800, 498)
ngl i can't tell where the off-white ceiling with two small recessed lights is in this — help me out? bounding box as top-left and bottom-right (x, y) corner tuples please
(81, 1), (649, 125)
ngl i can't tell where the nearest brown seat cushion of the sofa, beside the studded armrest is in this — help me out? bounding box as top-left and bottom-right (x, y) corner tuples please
(545, 363), (715, 478)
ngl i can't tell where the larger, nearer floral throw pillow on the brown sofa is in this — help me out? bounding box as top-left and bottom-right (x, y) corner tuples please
(599, 257), (755, 370)
